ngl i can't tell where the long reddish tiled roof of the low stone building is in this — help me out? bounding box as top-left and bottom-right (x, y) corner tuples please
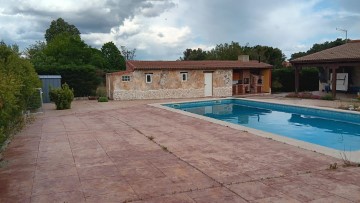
(126, 60), (272, 70)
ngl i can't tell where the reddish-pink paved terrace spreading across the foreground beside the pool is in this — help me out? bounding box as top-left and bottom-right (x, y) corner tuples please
(0, 100), (360, 203)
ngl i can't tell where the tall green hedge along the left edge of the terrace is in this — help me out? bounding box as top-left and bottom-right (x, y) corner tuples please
(0, 42), (41, 148)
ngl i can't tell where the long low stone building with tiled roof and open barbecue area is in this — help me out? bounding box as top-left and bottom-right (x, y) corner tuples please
(106, 56), (272, 100)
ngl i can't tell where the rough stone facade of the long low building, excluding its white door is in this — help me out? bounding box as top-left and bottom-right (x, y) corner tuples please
(107, 69), (232, 100)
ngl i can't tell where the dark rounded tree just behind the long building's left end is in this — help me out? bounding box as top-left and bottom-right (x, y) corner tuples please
(101, 42), (126, 71)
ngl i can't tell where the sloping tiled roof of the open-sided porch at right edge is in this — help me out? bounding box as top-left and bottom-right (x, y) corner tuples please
(290, 40), (360, 64)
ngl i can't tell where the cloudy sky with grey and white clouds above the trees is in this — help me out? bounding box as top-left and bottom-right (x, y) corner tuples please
(0, 0), (360, 60)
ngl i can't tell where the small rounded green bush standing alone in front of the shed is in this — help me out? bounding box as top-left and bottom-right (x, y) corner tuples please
(49, 83), (74, 110)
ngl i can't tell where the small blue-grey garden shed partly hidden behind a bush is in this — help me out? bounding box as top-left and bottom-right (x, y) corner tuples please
(39, 75), (61, 103)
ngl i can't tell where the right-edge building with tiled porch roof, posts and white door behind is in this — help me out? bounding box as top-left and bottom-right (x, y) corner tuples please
(290, 40), (360, 98)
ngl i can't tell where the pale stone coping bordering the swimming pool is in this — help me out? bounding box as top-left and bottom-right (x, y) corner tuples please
(148, 97), (360, 163)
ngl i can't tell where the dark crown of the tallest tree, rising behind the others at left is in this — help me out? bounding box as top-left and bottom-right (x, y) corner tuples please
(45, 18), (80, 43)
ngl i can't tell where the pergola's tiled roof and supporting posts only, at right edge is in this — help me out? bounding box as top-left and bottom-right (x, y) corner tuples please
(290, 40), (360, 98)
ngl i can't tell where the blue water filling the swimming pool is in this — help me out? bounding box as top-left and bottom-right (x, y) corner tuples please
(165, 99), (360, 151)
